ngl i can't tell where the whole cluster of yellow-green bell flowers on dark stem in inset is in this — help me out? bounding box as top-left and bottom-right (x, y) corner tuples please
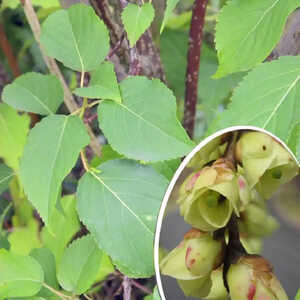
(160, 131), (299, 300)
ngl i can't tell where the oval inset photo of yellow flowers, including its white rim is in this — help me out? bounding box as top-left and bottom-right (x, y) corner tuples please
(155, 126), (300, 300)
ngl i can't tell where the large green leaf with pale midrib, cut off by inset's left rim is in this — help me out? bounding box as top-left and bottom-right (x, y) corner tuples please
(78, 159), (168, 277)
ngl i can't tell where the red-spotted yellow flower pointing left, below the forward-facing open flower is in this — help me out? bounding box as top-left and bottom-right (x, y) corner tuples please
(160, 229), (224, 280)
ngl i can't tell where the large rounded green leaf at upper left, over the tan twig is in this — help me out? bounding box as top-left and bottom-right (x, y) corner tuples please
(41, 4), (109, 72)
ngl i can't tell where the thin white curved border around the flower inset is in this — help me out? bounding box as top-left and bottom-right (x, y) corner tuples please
(154, 126), (299, 300)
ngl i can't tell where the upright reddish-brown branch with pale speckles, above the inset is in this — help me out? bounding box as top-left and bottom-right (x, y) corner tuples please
(183, 0), (208, 137)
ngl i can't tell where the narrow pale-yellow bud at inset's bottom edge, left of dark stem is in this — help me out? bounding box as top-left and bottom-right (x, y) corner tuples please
(204, 267), (228, 300)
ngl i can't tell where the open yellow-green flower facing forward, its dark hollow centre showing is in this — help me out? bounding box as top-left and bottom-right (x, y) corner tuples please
(178, 159), (239, 231)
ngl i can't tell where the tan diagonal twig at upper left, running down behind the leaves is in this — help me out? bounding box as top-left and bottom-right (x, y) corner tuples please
(21, 0), (101, 156)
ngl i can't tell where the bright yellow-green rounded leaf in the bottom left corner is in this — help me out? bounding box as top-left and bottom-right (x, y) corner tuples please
(0, 249), (44, 298)
